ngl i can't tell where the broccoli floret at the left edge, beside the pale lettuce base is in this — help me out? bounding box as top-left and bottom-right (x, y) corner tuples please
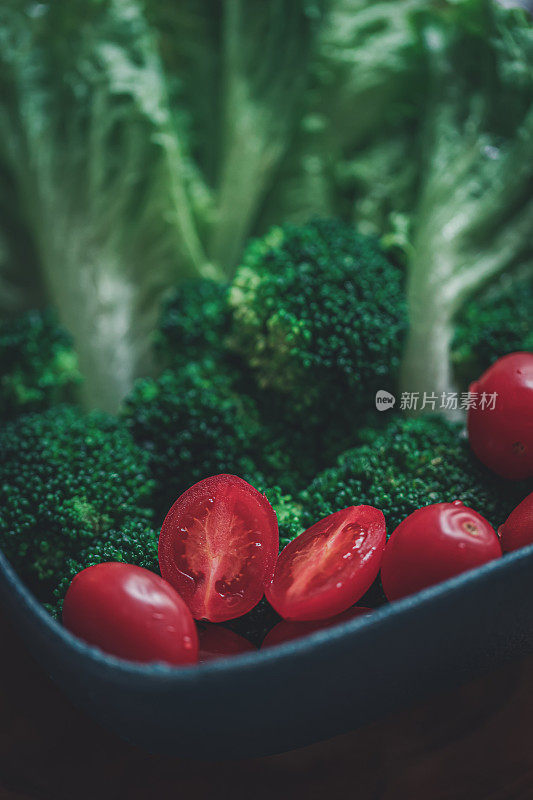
(0, 310), (81, 419)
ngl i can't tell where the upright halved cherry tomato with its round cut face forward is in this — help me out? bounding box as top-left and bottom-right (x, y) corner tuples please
(159, 475), (279, 622)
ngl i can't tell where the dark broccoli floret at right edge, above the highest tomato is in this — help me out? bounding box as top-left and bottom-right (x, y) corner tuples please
(452, 270), (533, 386)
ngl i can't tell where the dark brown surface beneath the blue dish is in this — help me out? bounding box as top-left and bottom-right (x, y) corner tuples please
(0, 616), (533, 800)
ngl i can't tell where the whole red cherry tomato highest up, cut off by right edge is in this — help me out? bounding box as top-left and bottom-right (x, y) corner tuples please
(468, 353), (533, 480)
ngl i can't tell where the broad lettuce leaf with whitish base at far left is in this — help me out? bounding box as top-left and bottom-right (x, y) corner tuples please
(0, 0), (205, 409)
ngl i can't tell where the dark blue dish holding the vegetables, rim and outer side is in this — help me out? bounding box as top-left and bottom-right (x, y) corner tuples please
(0, 546), (533, 758)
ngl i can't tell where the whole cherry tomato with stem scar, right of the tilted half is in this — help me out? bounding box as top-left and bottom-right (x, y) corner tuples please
(381, 500), (502, 600)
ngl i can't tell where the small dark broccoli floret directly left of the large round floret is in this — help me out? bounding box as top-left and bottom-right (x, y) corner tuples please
(155, 278), (231, 367)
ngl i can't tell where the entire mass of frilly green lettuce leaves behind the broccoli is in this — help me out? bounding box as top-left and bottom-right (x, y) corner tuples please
(0, 0), (533, 409)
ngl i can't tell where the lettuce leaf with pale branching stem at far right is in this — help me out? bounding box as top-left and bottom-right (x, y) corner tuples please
(403, 0), (533, 400)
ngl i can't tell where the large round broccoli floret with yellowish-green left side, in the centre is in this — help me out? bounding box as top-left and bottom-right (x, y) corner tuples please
(230, 220), (407, 427)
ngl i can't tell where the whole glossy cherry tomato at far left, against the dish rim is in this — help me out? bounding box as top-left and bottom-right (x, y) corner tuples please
(63, 562), (198, 664)
